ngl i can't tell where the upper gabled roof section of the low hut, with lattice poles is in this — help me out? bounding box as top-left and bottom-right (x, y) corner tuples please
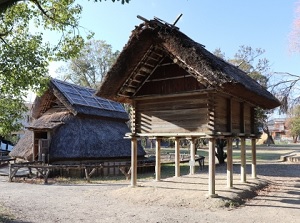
(32, 79), (128, 120)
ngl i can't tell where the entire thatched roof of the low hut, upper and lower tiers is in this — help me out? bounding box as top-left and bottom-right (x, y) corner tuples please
(10, 79), (145, 162)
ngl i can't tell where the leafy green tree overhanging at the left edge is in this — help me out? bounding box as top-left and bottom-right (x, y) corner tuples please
(0, 0), (129, 136)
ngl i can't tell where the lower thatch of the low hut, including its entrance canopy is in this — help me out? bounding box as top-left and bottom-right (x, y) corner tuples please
(10, 110), (145, 162)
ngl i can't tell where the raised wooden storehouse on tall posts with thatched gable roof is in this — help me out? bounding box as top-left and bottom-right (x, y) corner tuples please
(96, 18), (280, 196)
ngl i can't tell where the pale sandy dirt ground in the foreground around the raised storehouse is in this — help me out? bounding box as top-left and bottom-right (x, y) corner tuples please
(0, 152), (300, 223)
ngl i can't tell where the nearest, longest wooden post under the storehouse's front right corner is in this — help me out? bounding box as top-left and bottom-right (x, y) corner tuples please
(208, 138), (218, 197)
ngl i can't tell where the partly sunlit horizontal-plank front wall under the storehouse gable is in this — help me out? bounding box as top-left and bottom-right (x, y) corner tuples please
(135, 94), (209, 133)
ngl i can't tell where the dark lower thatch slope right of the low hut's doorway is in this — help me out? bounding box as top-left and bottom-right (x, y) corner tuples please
(50, 117), (145, 160)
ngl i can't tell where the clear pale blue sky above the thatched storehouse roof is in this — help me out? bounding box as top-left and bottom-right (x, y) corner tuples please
(28, 0), (300, 109)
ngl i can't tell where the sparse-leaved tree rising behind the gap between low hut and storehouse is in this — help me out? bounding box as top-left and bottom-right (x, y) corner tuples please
(59, 40), (119, 89)
